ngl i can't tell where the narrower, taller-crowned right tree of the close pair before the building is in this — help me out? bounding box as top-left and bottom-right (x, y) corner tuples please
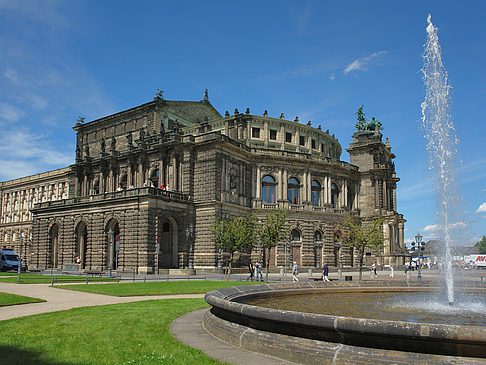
(258, 209), (287, 281)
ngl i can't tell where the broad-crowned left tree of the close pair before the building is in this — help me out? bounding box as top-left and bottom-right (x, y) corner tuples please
(211, 214), (257, 280)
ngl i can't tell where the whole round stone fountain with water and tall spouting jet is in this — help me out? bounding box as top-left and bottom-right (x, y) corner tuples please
(200, 15), (486, 364)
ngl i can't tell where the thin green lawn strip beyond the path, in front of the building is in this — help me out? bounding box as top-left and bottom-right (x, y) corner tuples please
(58, 280), (255, 297)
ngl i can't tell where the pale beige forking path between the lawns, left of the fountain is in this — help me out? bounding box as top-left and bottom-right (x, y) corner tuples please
(0, 282), (204, 320)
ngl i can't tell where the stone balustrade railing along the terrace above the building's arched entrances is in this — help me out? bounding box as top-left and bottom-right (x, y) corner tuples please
(34, 186), (189, 209)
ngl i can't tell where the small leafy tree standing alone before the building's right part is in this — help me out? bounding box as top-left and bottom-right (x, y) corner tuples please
(333, 217), (383, 280)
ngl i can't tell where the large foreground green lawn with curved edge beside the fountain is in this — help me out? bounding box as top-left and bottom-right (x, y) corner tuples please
(0, 299), (221, 365)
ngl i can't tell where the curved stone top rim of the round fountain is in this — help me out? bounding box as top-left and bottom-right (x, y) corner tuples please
(205, 282), (486, 346)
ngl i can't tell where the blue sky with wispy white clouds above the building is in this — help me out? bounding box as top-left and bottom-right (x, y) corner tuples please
(0, 0), (486, 244)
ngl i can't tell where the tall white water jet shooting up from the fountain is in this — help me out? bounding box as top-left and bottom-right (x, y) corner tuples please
(421, 14), (457, 305)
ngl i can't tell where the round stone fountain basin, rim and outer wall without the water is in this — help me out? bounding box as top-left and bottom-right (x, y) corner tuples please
(204, 281), (486, 363)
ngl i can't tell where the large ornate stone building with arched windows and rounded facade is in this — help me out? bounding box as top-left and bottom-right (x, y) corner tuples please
(0, 93), (405, 273)
